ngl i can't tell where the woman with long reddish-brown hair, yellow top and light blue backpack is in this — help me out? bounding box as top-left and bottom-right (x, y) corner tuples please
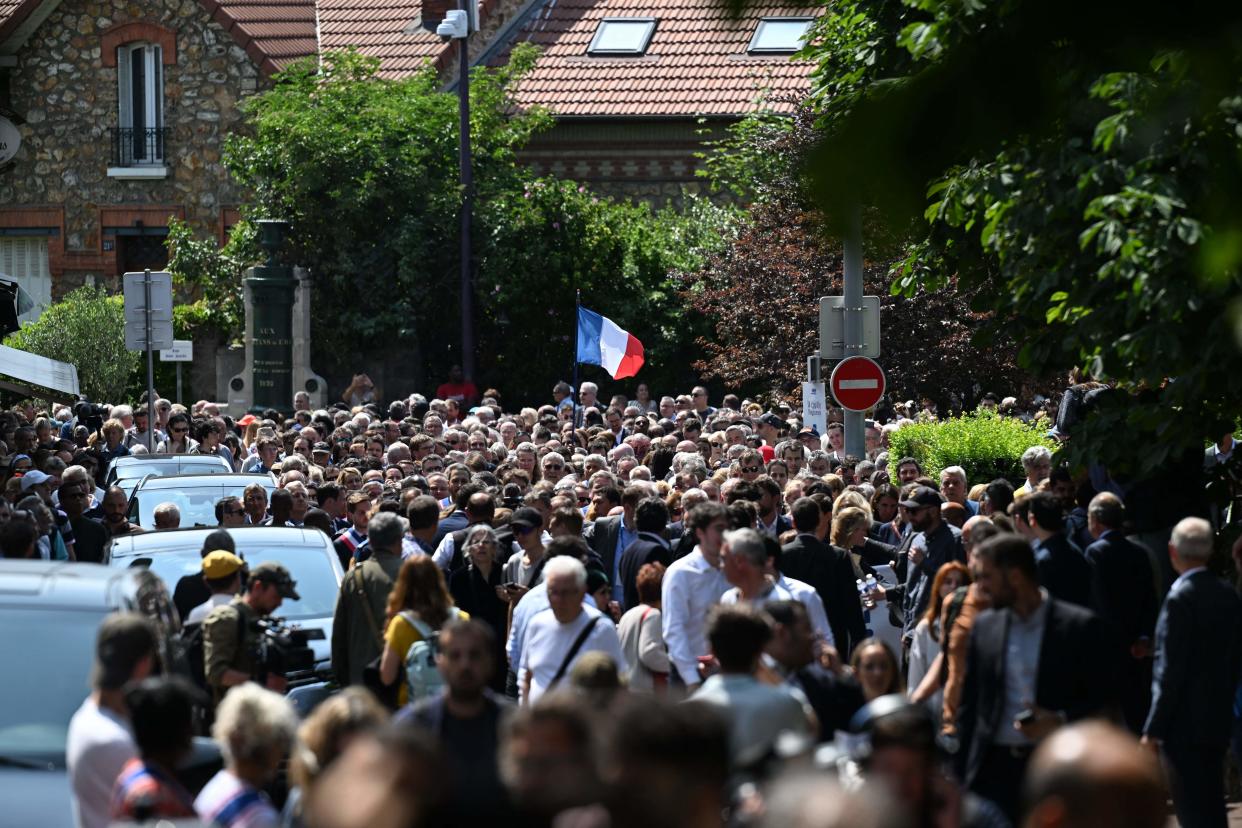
(380, 555), (469, 706)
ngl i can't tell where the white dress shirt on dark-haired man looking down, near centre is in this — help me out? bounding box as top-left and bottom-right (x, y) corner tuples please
(661, 546), (729, 685)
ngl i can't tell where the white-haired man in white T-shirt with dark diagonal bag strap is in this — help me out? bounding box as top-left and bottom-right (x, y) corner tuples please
(518, 555), (628, 705)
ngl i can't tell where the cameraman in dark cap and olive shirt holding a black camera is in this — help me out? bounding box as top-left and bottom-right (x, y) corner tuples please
(202, 561), (299, 703)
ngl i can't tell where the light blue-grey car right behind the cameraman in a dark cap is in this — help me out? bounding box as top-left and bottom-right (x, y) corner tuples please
(112, 531), (344, 715)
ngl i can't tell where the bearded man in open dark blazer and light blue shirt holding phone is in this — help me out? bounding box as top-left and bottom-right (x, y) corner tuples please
(956, 535), (1113, 822)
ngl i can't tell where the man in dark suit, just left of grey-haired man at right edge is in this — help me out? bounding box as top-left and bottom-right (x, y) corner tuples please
(1087, 492), (1160, 734)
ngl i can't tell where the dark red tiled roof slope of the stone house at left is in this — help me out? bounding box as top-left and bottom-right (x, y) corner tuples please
(196, 0), (318, 73)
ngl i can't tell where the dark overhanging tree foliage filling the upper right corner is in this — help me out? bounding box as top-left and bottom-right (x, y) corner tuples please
(807, 0), (1242, 473)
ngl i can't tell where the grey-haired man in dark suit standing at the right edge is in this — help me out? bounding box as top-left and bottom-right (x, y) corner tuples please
(1143, 518), (1242, 828)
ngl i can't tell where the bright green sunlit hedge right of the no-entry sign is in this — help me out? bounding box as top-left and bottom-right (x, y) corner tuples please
(888, 410), (1057, 485)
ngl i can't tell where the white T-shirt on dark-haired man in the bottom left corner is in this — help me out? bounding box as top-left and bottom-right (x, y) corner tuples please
(65, 696), (138, 828)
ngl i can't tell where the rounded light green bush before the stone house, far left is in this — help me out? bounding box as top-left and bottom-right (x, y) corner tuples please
(4, 287), (139, 402)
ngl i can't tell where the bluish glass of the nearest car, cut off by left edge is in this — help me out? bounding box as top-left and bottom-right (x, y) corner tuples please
(0, 606), (104, 757)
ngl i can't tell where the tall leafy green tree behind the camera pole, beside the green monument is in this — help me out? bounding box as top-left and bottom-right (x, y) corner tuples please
(225, 48), (548, 379)
